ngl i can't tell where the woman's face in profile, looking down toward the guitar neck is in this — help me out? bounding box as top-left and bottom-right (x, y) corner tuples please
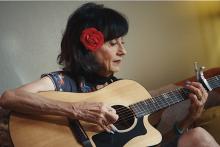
(94, 37), (126, 76)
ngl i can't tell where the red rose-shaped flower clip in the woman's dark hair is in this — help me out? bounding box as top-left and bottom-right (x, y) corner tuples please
(80, 28), (104, 52)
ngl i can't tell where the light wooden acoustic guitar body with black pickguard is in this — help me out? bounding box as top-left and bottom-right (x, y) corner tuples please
(9, 80), (162, 147)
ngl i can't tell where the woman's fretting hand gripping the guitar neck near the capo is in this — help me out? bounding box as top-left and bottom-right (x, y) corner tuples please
(185, 82), (208, 123)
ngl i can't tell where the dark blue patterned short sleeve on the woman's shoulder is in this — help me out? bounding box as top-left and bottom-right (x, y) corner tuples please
(41, 71), (78, 92)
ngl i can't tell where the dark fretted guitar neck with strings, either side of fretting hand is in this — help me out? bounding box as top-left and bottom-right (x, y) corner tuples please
(129, 75), (220, 118)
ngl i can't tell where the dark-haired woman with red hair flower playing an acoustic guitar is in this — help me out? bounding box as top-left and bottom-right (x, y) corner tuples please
(0, 3), (217, 147)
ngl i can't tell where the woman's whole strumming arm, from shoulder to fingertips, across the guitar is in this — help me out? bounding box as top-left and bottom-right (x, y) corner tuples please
(0, 77), (118, 131)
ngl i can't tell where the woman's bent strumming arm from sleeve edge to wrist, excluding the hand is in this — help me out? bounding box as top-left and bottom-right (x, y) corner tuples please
(0, 77), (74, 117)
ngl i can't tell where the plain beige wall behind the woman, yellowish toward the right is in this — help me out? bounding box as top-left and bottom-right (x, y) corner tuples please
(0, 1), (219, 93)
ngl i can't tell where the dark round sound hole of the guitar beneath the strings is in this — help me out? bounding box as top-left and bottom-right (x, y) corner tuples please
(112, 105), (135, 130)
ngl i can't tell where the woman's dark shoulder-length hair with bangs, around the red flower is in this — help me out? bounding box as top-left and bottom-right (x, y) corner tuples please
(57, 2), (128, 75)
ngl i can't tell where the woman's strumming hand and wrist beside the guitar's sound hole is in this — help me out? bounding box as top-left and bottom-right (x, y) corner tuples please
(72, 102), (118, 132)
